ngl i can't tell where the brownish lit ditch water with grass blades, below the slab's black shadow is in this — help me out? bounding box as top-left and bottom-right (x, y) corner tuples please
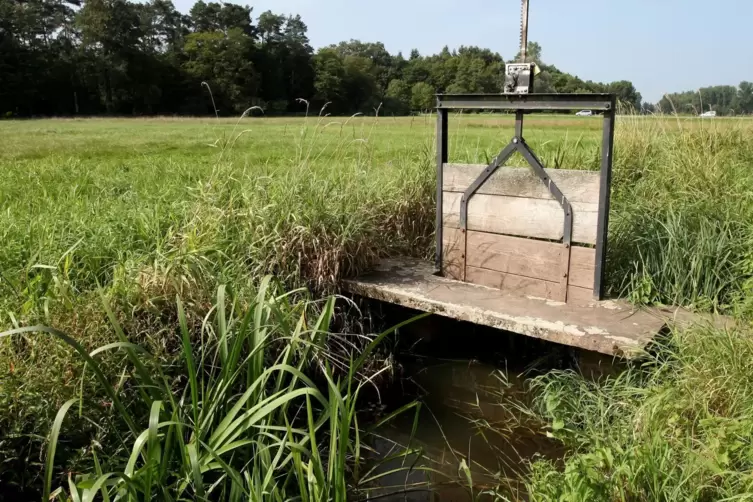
(364, 357), (561, 501)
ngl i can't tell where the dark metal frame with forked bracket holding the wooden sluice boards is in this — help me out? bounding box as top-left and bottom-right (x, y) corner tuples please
(436, 94), (616, 301)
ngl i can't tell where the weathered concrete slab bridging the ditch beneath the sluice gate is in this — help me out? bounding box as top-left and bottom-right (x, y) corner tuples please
(344, 259), (718, 358)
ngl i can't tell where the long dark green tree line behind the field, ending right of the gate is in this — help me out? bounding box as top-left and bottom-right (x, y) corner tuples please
(0, 0), (643, 116)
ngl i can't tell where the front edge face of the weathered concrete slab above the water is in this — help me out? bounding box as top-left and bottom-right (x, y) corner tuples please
(343, 280), (658, 359)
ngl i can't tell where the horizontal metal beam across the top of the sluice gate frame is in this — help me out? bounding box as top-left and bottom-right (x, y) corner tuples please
(437, 94), (615, 111)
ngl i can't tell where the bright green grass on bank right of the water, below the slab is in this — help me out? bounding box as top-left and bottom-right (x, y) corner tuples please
(528, 328), (753, 501)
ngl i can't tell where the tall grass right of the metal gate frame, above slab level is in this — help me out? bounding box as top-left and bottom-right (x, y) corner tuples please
(608, 118), (753, 313)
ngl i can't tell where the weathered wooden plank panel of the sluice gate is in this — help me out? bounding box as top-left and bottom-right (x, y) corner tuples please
(442, 163), (600, 302)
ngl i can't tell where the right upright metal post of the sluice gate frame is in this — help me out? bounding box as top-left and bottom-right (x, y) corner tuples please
(593, 97), (616, 300)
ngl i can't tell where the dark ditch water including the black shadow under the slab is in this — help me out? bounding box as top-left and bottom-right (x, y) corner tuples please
(356, 306), (611, 502)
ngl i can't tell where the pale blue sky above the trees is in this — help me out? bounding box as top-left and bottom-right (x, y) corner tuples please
(174, 0), (753, 102)
